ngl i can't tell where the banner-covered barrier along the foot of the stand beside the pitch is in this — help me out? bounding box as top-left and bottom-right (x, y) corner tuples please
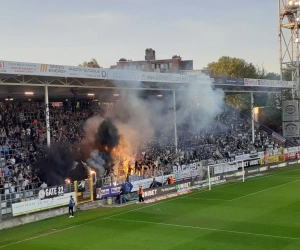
(0, 147), (300, 220)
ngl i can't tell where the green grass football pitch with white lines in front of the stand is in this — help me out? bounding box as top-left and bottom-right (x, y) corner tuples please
(0, 166), (300, 250)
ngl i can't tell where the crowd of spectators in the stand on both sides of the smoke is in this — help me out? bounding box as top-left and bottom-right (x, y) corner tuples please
(0, 102), (284, 195)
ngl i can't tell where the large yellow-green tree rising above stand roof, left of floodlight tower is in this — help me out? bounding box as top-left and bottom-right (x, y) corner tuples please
(207, 56), (257, 78)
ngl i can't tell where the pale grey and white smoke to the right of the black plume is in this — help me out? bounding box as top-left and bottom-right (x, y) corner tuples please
(102, 77), (224, 155)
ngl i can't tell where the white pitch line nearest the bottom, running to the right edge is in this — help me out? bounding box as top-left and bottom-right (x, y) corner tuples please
(109, 219), (300, 240)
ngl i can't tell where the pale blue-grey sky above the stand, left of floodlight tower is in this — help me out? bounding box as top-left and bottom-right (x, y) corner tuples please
(0, 0), (279, 72)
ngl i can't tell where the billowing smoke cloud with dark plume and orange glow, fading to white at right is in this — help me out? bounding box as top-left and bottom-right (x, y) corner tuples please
(80, 74), (224, 180)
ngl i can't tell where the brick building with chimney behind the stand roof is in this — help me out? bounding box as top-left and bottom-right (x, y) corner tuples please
(111, 48), (193, 73)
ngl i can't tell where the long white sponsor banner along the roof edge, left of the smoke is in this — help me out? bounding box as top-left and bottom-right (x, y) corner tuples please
(0, 61), (190, 83)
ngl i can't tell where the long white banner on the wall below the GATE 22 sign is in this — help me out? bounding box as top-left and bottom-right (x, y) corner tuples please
(12, 192), (75, 216)
